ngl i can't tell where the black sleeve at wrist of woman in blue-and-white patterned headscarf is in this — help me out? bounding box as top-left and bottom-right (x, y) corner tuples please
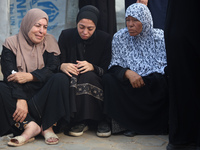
(108, 66), (128, 81)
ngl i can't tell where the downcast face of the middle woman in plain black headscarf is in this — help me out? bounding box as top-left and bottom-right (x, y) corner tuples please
(77, 19), (96, 40)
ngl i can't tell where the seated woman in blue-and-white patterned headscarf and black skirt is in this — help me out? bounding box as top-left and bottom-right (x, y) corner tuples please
(103, 3), (168, 136)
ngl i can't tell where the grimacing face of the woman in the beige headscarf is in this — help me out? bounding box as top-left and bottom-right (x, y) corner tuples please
(28, 19), (48, 44)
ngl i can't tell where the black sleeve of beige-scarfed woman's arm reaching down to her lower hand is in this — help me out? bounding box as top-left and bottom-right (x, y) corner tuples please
(1, 46), (27, 100)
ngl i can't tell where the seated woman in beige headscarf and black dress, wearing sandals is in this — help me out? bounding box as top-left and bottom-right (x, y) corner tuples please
(0, 9), (69, 146)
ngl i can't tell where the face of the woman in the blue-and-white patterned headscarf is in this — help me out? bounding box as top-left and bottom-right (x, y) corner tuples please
(126, 16), (142, 36)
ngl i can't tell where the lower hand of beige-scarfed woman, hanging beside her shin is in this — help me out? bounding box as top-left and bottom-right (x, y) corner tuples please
(13, 99), (28, 122)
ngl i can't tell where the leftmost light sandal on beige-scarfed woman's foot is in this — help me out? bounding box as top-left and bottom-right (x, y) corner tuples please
(8, 136), (35, 147)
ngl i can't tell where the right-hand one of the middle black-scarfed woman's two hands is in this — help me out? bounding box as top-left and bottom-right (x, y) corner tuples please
(76, 61), (94, 73)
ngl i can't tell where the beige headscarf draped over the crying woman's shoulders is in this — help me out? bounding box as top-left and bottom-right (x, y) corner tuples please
(3, 8), (60, 72)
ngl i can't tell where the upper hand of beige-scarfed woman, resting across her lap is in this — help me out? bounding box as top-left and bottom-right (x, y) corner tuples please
(7, 72), (34, 84)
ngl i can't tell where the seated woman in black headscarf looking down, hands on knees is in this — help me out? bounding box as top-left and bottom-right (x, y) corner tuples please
(58, 5), (112, 136)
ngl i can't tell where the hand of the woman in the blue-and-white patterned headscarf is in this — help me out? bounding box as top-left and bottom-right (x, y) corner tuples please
(125, 70), (145, 88)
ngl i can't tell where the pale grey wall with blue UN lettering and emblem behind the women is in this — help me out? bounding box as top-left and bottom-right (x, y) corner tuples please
(0, 0), (125, 53)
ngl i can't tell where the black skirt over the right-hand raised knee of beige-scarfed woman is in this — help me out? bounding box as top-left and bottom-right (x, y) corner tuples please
(28, 73), (70, 130)
